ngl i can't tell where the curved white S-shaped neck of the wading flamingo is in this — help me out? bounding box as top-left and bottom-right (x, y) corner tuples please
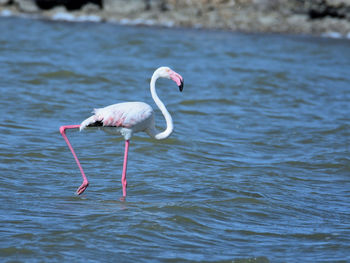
(150, 72), (174, 140)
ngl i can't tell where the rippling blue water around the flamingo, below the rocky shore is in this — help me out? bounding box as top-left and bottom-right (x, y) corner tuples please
(0, 18), (350, 262)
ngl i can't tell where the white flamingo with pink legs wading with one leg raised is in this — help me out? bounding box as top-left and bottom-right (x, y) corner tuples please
(60, 67), (184, 201)
